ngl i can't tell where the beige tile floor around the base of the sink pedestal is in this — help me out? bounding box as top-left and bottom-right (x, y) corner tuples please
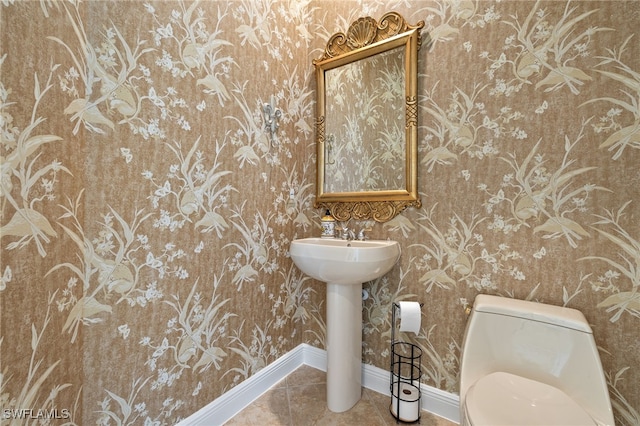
(225, 365), (456, 426)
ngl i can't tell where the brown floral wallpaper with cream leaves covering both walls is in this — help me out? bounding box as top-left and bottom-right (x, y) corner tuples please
(0, 0), (640, 425)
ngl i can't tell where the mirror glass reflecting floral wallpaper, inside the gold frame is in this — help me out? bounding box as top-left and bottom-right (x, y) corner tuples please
(323, 47), (407, 193)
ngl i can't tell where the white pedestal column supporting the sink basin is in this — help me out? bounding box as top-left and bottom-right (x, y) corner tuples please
(326, 283), (362, 413)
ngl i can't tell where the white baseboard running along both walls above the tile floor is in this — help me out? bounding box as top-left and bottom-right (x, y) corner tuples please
(178, 343), (460, 426)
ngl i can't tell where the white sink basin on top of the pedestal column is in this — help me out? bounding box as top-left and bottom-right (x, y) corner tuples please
(289, 238), (400, 285)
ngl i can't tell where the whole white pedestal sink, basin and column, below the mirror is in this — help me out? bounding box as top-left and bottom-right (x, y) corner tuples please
(289, 238), (400, 413)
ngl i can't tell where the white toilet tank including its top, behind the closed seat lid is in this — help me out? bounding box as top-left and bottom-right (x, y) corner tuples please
(460, 295), (613, 424)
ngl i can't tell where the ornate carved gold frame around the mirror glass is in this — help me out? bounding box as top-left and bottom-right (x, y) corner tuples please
(313, 12), (424, 222)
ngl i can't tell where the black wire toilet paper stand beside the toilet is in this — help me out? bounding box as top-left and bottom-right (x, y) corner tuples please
(389, 302), (423, 423)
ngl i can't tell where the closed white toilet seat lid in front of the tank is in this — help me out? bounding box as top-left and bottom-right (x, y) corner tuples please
(464, 372), (596, 426)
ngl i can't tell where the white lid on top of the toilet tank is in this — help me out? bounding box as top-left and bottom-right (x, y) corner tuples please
(473, 294), (592, 334)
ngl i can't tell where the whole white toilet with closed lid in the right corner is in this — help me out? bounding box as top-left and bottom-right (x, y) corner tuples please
(460, 295), (614, 426)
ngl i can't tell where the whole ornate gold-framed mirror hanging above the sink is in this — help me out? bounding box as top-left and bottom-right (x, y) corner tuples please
(313, 12), (424, 222)
